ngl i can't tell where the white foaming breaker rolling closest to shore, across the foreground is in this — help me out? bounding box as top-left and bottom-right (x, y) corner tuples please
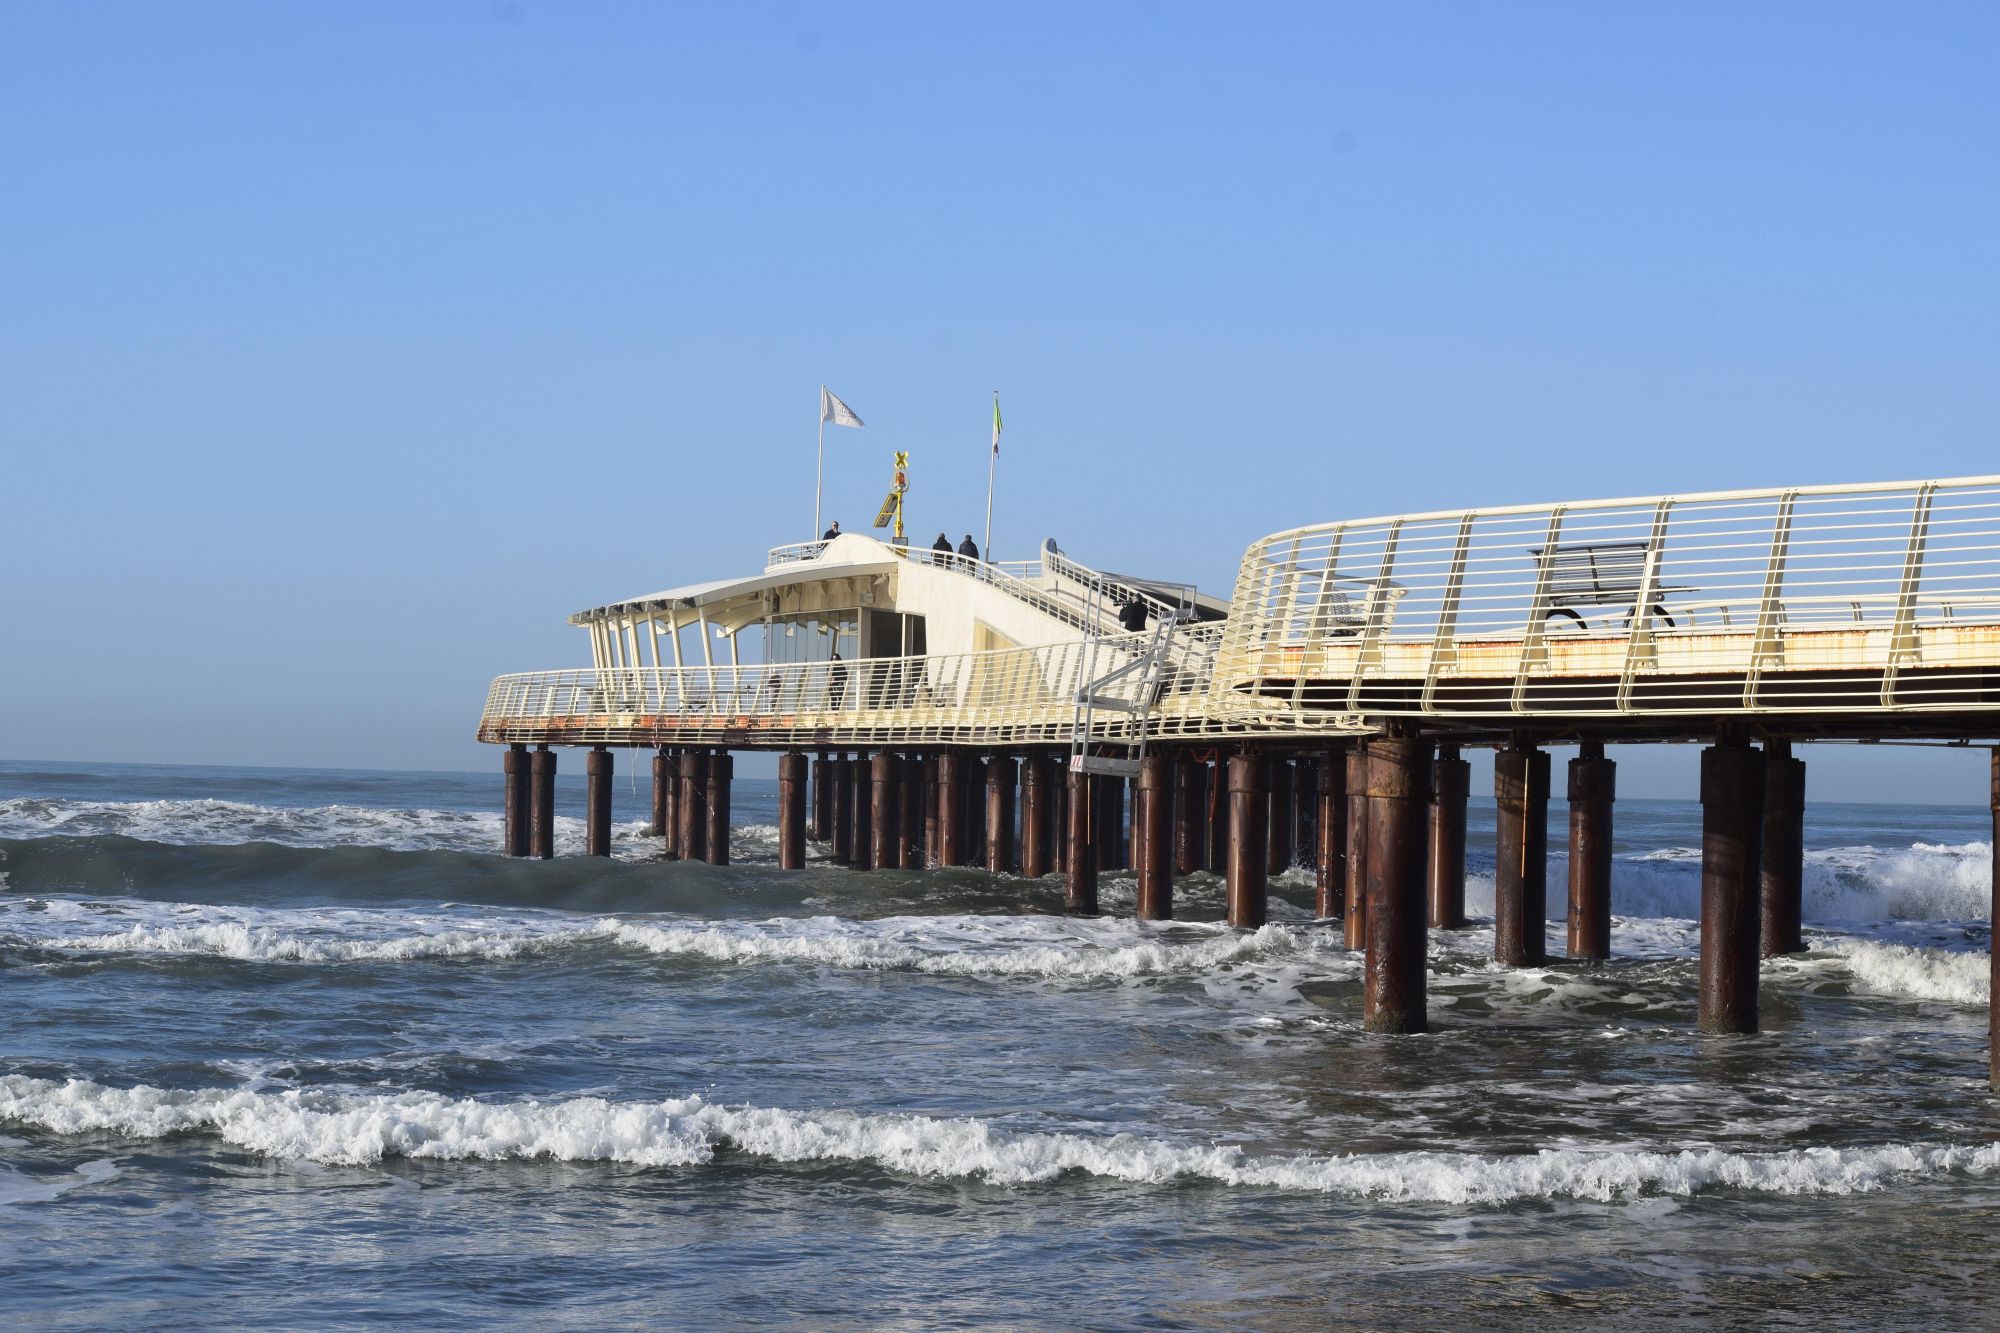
(0, 1075), (2000, 1205)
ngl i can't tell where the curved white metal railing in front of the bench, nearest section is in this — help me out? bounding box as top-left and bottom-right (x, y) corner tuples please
(1214, 476), (2000, 721)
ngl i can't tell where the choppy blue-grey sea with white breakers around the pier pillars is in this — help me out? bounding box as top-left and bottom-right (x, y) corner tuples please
(0, 761), (2000, 1329)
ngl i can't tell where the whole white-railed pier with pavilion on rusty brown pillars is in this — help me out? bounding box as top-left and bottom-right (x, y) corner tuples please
(478, 476), (2000, 1085)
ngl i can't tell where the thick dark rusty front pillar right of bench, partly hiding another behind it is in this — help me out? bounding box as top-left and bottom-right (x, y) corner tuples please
(1698, 735), (1764, 1033)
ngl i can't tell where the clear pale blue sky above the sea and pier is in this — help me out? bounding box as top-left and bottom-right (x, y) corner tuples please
(0, 0), (2000, 801)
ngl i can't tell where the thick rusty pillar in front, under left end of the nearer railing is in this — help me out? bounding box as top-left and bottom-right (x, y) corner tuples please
(1362, 737), (1430, 1033)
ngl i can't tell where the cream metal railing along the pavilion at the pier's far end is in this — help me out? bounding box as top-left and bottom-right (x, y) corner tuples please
(480, 624), (1242, 745)
